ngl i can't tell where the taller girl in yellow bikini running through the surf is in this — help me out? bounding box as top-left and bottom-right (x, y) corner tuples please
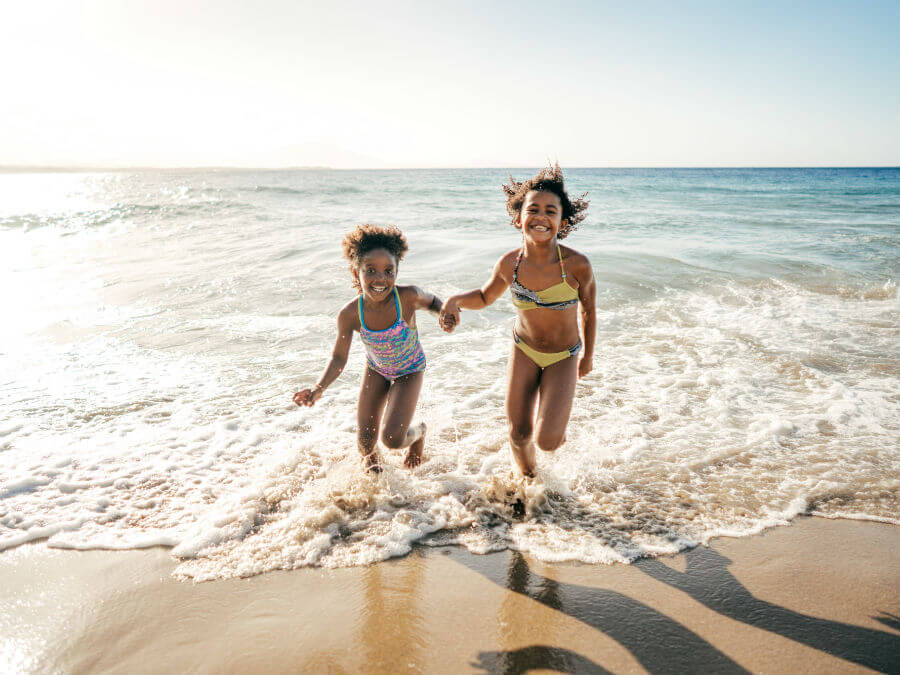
(440, 165), (597, 476)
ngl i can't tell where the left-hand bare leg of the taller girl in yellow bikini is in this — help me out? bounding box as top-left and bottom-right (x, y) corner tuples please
(506, 344), (541, 477)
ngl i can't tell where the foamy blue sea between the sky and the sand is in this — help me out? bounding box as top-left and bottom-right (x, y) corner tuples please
(0, 169), (900, 580)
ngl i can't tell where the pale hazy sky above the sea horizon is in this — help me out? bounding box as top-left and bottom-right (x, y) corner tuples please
(0, 0), (900, 167)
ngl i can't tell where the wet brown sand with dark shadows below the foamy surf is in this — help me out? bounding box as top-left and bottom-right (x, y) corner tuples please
(0, 518), (900, 673)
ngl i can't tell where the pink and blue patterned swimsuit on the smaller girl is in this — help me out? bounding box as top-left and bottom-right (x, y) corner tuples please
(359, 286), (425, 382)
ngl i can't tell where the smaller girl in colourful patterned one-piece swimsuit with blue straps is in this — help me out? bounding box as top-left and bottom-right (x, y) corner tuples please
(294, 225), (444, 472)
